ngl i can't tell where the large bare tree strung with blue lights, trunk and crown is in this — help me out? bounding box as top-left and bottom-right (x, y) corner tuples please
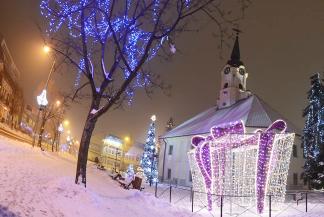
(40, 0), (248, 186)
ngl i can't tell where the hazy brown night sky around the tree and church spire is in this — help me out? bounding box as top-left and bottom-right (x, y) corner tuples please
(0, 0), (324, 141)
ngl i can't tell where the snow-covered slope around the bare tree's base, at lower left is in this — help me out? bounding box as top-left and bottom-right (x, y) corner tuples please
(0, 137), (197, 217)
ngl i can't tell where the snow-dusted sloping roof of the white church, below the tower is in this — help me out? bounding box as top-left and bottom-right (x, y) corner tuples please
(161, 95), (301, 138)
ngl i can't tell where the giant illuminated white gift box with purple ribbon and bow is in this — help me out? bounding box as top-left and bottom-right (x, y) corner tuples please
(188, 120), (295, 213)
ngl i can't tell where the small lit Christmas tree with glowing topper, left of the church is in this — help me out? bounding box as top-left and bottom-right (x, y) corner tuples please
(141, 115), (158, 185)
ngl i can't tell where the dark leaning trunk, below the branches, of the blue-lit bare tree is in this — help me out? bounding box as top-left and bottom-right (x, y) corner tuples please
(75, 110), (97, 187)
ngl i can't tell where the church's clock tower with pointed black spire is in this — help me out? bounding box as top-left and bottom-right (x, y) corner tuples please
(217, 29), (251, 109)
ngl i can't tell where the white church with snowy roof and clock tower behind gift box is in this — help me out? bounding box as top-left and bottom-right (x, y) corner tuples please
(159, 32), (307, 190)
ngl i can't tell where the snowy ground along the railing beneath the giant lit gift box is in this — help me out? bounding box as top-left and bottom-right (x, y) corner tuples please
(144, 184), (324, 217)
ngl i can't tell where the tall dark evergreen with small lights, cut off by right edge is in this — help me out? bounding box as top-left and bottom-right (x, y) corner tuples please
(302, 73), (324, 189)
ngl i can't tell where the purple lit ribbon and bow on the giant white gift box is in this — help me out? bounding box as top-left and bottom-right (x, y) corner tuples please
(192, 120), (286, 213)
